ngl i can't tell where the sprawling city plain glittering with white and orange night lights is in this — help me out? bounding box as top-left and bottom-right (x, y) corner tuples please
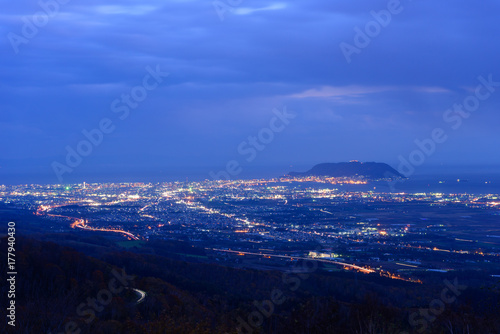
(0, 177), (500, 284)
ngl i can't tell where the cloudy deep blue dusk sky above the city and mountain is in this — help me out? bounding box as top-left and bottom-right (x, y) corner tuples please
(0, 0), (500, 184)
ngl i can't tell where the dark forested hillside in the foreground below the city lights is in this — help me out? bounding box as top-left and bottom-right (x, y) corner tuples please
(0, 237), (500, 334)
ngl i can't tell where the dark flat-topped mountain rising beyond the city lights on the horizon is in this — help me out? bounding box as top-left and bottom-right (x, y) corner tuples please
(288, 160), (404, 179)
